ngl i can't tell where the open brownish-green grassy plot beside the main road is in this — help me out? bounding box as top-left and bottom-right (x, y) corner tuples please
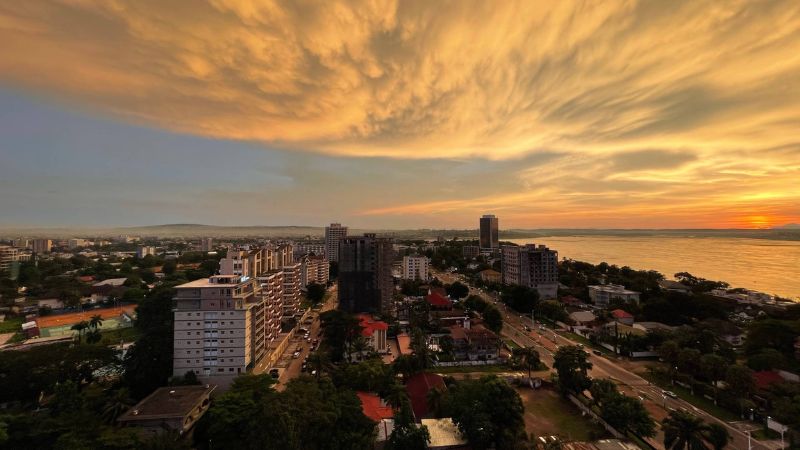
(517, 387), (607, 441)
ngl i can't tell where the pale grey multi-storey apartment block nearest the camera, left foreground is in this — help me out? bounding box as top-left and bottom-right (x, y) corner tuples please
(173, 275), (266, 384)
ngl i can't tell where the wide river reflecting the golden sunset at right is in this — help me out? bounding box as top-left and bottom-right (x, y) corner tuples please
(510, 236), (800, 301)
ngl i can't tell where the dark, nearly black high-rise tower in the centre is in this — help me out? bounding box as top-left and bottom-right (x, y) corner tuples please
(339, 234), (394, 313)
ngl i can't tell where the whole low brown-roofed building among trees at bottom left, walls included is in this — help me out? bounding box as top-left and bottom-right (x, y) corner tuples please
(117, 385), (217, 435)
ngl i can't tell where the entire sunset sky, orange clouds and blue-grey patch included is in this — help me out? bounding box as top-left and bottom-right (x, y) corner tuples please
(0, 0), (800, 228)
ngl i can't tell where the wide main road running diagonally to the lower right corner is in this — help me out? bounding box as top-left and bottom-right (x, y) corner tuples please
(435, 272), (780, 450)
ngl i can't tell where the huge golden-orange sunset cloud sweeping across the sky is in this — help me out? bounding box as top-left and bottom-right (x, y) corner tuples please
(0, 0), (800, 226)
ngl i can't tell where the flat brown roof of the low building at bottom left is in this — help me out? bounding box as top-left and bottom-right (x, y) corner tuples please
(117, 385), (217, 422)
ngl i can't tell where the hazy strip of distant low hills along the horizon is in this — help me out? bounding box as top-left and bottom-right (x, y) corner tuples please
(0, 224), (800, 241)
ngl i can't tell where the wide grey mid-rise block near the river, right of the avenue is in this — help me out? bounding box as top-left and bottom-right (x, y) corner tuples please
(502, 244), (558, 300)
